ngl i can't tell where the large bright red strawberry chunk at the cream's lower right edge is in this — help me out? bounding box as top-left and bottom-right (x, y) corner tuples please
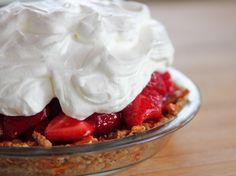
(122, 94), (161, 127)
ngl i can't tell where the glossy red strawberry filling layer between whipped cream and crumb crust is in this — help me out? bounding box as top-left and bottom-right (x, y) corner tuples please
(0, 72), (175, 142)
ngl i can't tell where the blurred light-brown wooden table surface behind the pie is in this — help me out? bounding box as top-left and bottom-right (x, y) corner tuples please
(115, 0), (236, 176)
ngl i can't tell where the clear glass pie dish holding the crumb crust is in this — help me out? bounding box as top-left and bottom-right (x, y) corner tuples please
(0, 68), (201, 176)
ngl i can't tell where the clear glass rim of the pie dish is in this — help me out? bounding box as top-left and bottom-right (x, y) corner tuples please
(0, 67), (201, 157)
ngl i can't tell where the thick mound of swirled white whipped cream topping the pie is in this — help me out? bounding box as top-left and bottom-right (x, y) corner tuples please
(0, 0), (174, 120)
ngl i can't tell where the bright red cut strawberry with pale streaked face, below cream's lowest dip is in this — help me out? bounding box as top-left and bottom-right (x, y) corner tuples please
(45, 113), (94, 142)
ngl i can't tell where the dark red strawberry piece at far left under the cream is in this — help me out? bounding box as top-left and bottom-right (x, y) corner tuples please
(3, 108), (48, 139)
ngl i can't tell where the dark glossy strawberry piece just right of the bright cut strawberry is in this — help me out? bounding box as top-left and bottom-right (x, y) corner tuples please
(87, 113), (123, 136)
